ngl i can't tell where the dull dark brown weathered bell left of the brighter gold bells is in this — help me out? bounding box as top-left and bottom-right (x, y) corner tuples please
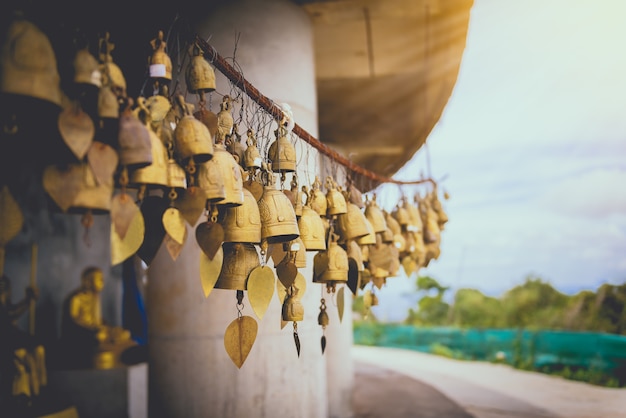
(119, 108), (154, 169)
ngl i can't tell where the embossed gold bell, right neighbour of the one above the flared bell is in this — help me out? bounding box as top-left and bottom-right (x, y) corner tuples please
(257, 186), (300, 244)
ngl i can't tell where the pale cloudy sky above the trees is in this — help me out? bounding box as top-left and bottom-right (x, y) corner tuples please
(374, 0), (626, 320)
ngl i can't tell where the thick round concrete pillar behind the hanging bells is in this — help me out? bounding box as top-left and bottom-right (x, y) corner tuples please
(147, 0), (334, 417)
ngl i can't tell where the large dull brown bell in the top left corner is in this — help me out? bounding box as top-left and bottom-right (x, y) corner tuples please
(0, 19), (62, 106)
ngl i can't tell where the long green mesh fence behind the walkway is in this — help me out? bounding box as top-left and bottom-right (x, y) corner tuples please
(354, 323), (626, 380)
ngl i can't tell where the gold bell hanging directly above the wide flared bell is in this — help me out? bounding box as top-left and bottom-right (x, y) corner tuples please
(222, 189), (261, 244)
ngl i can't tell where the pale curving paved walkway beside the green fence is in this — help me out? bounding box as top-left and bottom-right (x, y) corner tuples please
(352, 346), (626, 418)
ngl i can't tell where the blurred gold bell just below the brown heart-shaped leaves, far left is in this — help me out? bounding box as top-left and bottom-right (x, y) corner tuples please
(68, 163), (115, 213)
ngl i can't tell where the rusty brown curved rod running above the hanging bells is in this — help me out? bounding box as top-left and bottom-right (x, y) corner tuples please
(196, 35), (435, 185)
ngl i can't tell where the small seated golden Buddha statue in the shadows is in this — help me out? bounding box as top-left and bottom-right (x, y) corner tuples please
(61, 267), (136, 369)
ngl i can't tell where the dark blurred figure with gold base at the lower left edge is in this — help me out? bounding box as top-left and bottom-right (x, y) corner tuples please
(0, 275), (47, 410)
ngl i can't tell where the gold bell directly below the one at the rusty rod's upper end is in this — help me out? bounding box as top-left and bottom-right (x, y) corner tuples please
(174, 95), (214, 164)
